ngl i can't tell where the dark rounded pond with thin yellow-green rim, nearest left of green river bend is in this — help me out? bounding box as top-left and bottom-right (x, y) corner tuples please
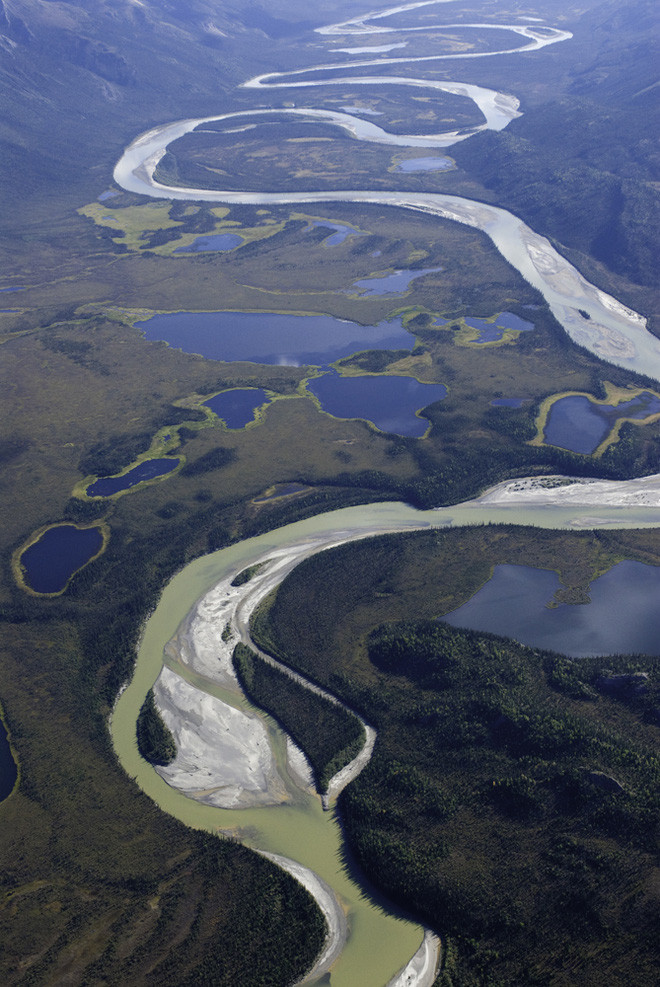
(20, 524), (103, 593)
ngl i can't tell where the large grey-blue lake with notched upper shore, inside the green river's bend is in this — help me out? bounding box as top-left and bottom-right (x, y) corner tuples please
(442, 561), (660, 658)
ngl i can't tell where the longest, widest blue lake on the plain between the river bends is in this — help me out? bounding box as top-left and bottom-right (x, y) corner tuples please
(136, 312), (415, 367)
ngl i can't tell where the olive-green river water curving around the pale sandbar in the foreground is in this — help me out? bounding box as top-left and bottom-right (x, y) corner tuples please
(111, 503), (660, 987)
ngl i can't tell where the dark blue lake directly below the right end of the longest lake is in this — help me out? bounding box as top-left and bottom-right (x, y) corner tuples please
(307, 371), (447, 438)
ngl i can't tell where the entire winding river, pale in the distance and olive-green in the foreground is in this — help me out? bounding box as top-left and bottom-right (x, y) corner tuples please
(112, 0), (660, 987)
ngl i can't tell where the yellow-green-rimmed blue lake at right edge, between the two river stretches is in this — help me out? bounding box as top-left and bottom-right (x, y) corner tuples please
(543, 391), (660, 454)
